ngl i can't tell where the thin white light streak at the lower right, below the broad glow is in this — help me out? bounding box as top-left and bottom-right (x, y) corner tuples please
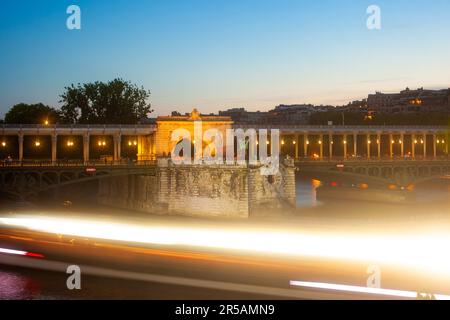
(290, 281), (450, 300)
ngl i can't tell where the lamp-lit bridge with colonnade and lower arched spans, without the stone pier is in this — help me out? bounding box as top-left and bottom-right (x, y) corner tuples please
(0, 115), (450, 194)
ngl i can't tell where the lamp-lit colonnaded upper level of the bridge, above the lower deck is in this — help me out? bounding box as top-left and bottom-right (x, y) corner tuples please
(0, 122), (450, 163)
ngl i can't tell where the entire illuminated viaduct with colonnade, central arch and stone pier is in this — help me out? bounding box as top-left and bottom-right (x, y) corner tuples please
(0, 109), (450, 217)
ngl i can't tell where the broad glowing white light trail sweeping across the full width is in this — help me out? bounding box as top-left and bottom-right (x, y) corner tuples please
(0, 216), (450, 277)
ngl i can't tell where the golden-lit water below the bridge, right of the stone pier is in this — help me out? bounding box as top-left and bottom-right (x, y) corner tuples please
(296, 175), (450, 221)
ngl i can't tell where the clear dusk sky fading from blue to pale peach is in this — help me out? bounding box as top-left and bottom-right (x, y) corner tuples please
(0, 0), (450, 118)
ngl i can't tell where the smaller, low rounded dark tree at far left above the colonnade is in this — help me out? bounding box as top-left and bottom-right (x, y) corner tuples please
(4, 103), (59, 124)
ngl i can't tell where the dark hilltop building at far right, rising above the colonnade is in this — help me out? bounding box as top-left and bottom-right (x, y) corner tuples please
(367, 88), (450, 113)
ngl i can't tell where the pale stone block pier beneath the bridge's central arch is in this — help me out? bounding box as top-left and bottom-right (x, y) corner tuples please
(98, 159), (296, 218)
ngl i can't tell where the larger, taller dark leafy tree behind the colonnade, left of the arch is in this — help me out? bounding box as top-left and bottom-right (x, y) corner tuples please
(60, 79), (153, 124)
